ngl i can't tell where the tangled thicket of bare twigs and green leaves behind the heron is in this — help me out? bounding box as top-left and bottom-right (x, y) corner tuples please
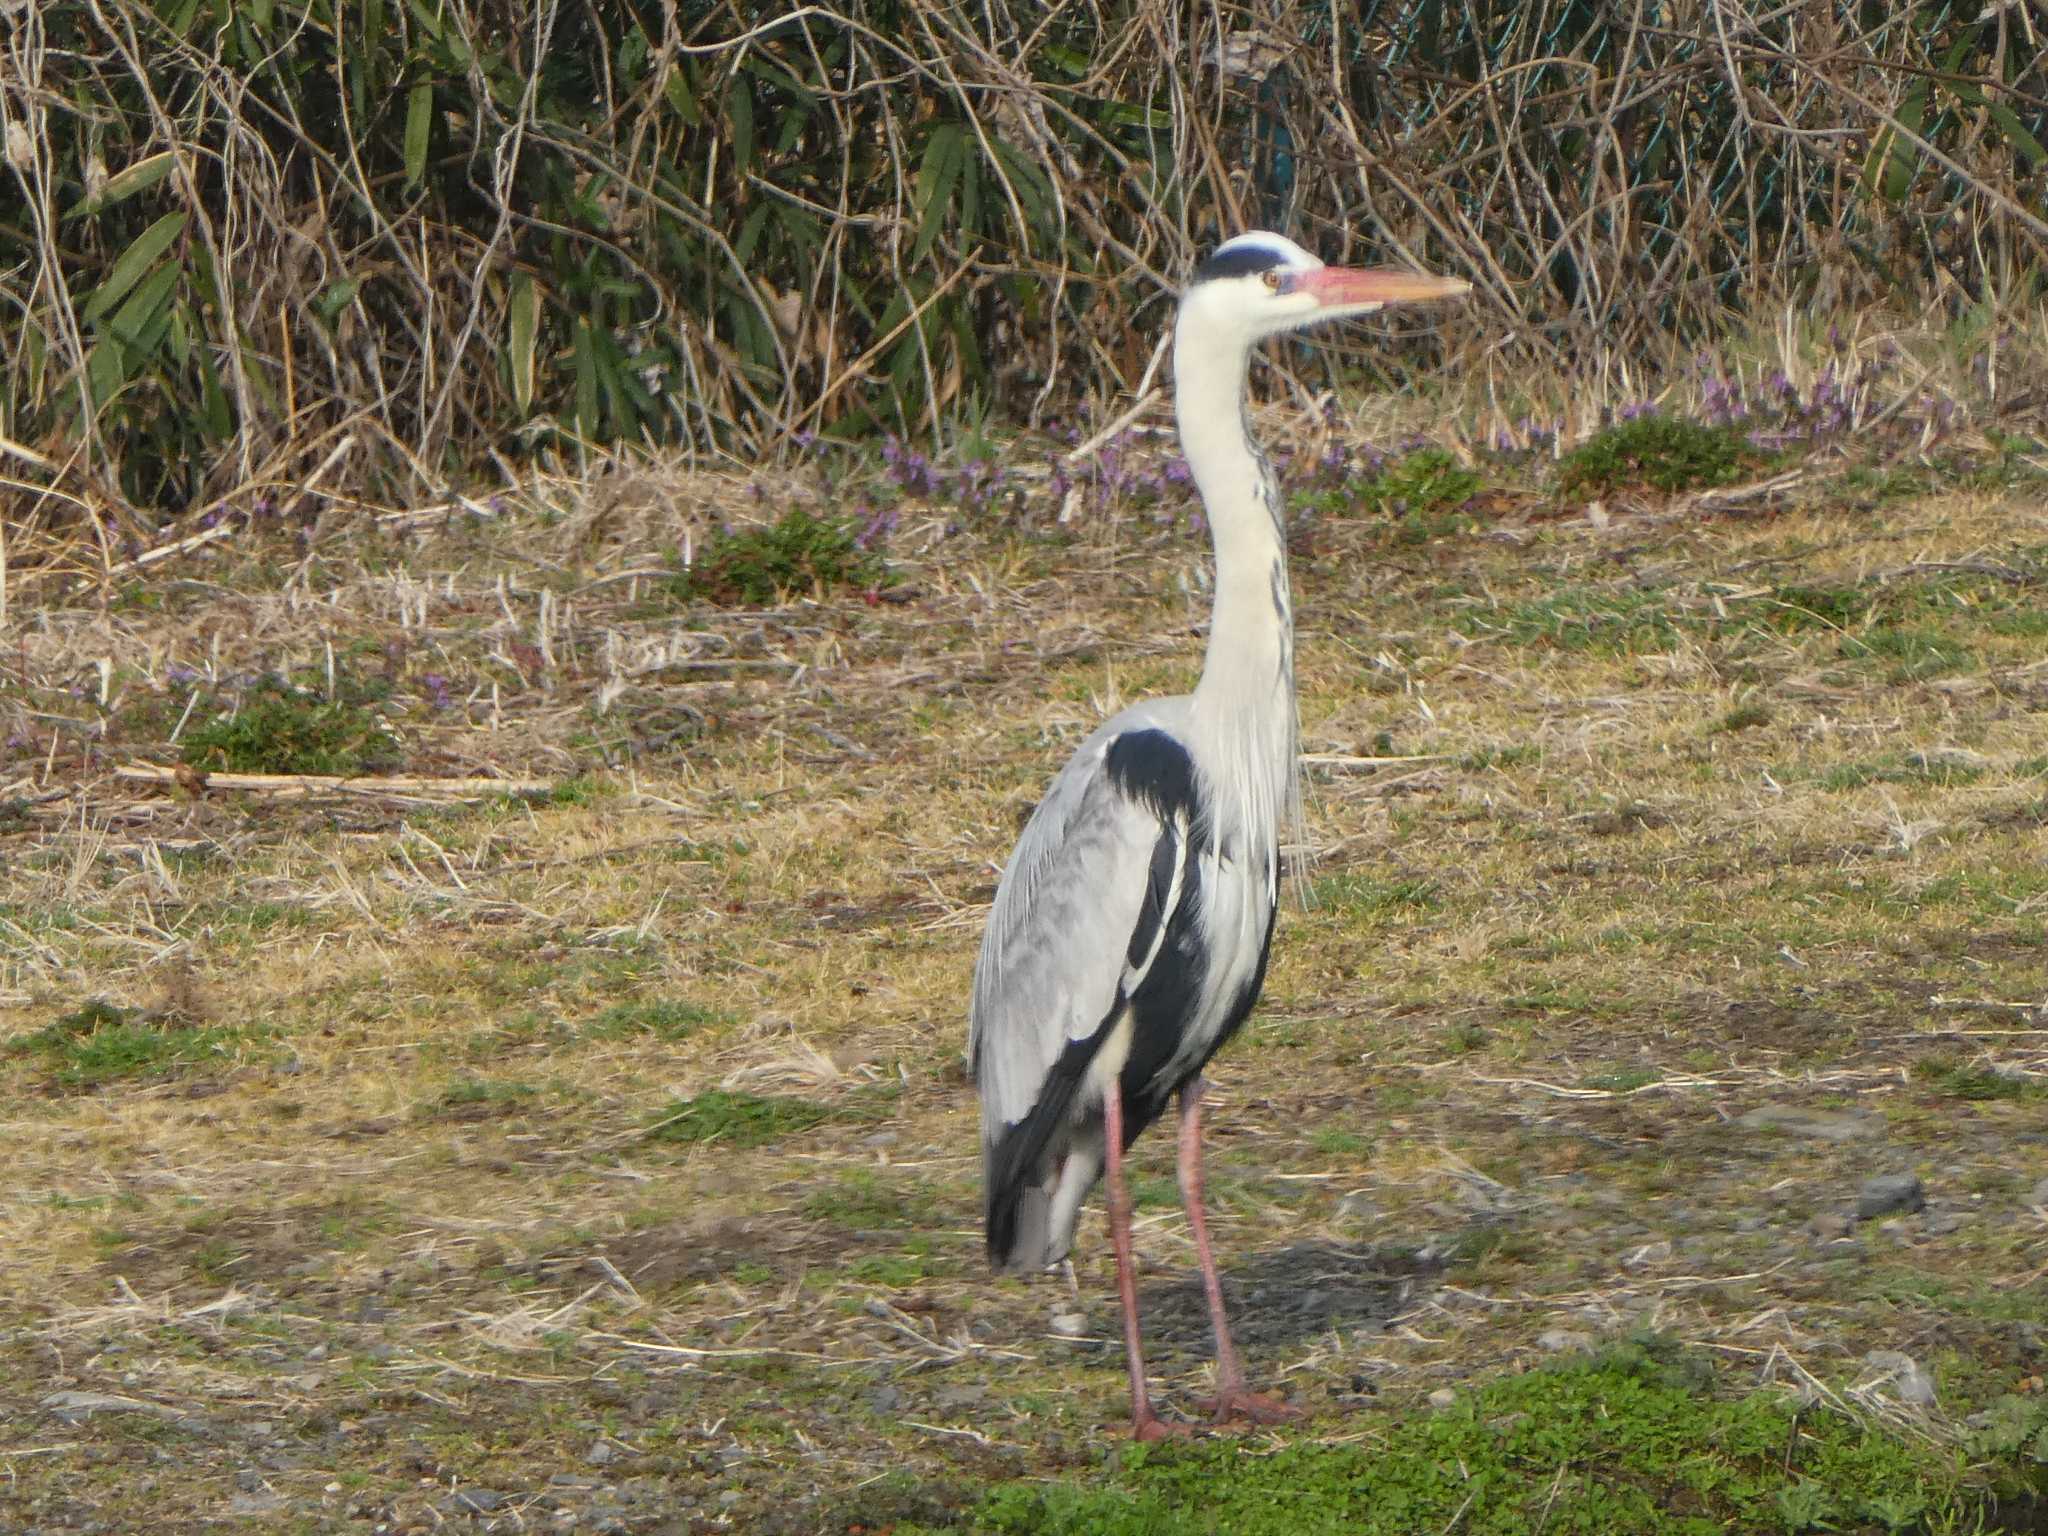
(0, 0), (2048, 539)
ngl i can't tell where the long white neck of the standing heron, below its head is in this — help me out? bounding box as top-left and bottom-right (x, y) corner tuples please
(1174, 319), (1296, 848)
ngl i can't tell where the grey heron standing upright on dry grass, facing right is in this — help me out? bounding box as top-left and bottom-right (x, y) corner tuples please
(969, 231), (1468, 1440)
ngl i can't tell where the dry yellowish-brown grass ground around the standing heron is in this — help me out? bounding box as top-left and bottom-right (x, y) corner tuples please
(0, 417), (2048, 1530)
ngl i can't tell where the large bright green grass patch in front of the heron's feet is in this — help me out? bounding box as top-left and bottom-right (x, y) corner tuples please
(897, 1343), (1998, 1536)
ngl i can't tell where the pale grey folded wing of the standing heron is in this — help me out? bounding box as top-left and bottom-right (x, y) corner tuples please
(969, 721), (1188, 1143)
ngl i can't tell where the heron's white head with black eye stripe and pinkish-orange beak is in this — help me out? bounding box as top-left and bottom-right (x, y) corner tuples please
(1180, 229), (1473, 346)
